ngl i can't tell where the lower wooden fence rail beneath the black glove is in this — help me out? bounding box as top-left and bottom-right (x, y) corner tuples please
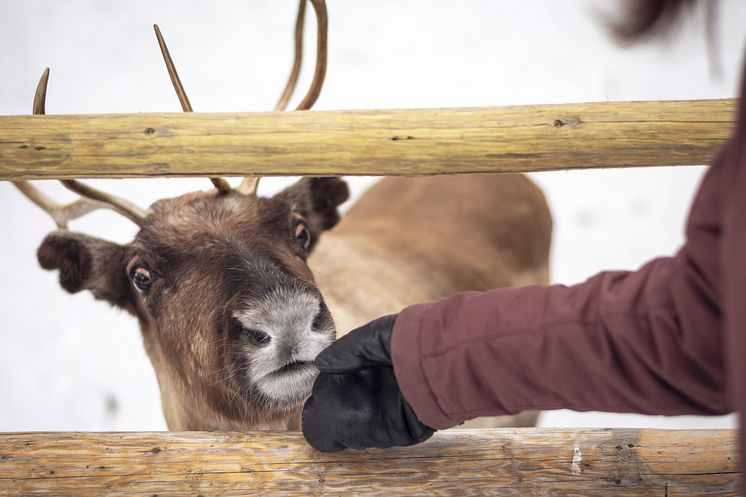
(0, 428), (739, 497)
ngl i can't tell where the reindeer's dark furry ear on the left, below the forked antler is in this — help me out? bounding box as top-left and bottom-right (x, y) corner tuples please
(36, 231), (131, 310)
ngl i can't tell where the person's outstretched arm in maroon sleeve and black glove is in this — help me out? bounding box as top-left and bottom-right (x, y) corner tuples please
(302, 140), (732, 451)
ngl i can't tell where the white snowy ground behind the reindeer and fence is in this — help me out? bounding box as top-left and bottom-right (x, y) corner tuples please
(0, 0), (746, 431)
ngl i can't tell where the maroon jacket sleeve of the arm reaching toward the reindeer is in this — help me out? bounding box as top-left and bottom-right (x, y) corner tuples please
(392, 147), (728, 429)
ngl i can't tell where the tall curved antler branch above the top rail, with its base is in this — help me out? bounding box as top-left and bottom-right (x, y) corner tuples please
(237, 0), (329, 195)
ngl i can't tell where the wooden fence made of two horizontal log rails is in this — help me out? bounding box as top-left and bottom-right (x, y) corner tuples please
(0, 100), (739, 497)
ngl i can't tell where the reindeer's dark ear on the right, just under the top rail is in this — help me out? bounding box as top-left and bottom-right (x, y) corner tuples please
(275, 178), (350, 232)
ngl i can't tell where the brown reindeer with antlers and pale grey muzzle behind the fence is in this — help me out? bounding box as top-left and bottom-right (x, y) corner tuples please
(10, 0), (552, 430)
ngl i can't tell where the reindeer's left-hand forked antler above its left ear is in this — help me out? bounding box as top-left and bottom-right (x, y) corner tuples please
(13, 68), (146, 229)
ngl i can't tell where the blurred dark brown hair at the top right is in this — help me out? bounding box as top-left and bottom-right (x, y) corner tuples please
(608, 0), (694, 44)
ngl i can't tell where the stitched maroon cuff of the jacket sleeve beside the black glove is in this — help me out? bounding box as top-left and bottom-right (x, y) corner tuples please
(391, 304), (459, 430)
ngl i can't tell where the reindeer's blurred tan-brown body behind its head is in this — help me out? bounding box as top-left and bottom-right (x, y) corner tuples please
(309, 175), (552, 337)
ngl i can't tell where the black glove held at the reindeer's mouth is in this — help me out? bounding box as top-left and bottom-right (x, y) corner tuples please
(301, 315), (434, 452)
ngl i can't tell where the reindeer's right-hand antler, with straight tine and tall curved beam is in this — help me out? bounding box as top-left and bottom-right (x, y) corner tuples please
(153, 0), (328, 195)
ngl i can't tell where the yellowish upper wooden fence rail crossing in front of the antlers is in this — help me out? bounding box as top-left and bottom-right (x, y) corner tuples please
(0, 100), (734, 180)
